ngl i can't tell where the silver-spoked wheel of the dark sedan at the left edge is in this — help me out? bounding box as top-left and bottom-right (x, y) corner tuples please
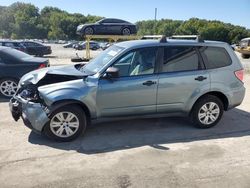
(0, 78), (18, 98)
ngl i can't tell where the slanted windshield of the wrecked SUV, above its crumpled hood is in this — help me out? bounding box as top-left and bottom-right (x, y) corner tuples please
(80, 45), (124, 74)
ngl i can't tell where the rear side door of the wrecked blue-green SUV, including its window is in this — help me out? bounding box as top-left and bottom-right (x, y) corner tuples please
(157, 46), (210, 113)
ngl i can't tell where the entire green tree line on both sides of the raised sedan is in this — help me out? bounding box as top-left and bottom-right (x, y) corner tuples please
(0, 2), (250, 43)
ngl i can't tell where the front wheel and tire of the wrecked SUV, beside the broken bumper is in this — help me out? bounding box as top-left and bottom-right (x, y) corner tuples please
(43, 105), (87, 142)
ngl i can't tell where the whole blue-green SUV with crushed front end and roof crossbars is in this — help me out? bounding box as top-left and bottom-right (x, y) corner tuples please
(10, 35), (245, 141)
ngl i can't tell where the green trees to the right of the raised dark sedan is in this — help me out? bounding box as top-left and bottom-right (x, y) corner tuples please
(137, 18), (250, 43)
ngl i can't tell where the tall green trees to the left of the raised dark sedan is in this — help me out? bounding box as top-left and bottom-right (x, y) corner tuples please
(0, 2), (102, 40)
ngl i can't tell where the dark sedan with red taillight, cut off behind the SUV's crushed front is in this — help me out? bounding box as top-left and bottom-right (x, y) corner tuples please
(0, 47), (49, 97)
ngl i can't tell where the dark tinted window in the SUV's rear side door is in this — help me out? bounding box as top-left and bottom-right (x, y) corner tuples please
(161, 46), (200, 72)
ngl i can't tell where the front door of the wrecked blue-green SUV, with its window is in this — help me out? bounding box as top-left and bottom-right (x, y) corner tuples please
(97, 48), (158, 117)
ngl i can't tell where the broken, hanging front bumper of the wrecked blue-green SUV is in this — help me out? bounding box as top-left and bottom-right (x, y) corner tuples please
(9, 97), (49, 132)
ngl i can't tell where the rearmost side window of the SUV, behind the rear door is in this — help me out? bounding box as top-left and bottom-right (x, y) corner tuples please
(200, 47), (232, 69)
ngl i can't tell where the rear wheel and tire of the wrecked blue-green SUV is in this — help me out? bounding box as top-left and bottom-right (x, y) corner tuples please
(191, 95), (224, 129)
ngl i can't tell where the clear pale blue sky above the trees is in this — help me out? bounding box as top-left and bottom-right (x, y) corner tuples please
(0, 0), (250, 29)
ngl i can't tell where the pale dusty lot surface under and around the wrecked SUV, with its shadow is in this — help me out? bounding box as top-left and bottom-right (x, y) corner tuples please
(0, 46), (250, 188)
